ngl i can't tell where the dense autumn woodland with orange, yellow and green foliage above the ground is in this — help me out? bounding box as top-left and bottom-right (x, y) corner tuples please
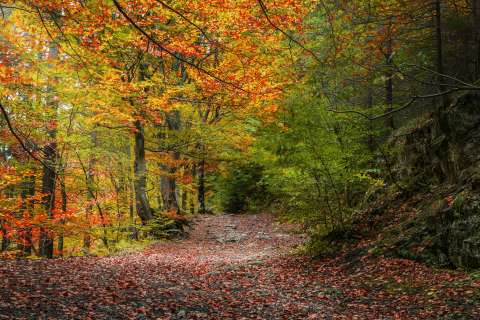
(0, 0), (480, 261)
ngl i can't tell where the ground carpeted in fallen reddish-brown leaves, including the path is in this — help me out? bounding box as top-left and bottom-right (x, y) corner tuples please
(0, 215), (480, 319)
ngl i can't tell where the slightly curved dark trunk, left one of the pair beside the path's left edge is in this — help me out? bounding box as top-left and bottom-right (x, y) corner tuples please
(133, 120), (153, 224)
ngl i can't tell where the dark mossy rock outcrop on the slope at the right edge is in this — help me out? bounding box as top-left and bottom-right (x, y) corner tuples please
(383, 93), (480, 268)
